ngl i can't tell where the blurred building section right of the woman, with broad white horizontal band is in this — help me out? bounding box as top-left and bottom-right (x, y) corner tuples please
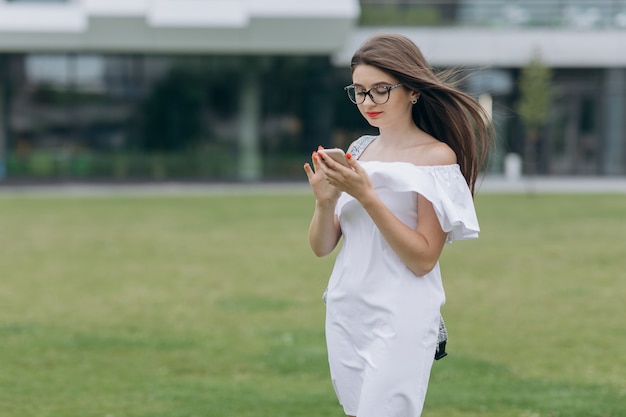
(354, 0), (626, 175)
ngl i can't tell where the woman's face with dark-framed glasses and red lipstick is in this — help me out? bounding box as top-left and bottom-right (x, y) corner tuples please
(352, 64), (417, 129)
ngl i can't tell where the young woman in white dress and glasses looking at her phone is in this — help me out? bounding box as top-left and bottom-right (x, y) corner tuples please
(304, 35), (492, 417)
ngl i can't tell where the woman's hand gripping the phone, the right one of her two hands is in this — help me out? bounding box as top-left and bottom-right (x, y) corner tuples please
(318, 152), (375, 202)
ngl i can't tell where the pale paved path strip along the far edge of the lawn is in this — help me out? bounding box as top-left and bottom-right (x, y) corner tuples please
(0, 176), (626, 197)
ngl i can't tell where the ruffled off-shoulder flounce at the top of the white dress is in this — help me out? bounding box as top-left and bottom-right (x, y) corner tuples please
(339, 161), (480, 243)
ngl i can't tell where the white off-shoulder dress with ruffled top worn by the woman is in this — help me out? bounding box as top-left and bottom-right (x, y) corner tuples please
(326, 137), (479, 417)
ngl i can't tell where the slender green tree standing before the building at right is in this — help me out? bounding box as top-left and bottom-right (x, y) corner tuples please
(516, 54), (552, 175)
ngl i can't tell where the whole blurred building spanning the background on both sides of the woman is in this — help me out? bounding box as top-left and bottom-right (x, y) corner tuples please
(0, 0), (626, 180)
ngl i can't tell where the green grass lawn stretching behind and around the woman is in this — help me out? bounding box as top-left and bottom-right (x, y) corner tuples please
(0, 194), (626, 417)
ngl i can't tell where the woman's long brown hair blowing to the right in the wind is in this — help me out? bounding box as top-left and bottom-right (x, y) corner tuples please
(350, 34), (495, 195)
